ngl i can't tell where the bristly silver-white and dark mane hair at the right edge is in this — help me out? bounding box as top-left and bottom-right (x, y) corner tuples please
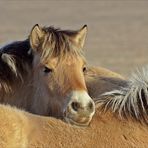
(96, 66), (148, 123)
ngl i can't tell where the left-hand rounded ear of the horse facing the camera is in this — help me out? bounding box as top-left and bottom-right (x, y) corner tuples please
(29, 24), (45, 51)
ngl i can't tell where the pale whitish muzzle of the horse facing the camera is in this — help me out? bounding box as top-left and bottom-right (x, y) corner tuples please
(64, 91), (95, 126)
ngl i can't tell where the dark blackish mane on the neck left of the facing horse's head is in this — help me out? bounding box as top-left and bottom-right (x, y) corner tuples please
(0, 40), (33, 91)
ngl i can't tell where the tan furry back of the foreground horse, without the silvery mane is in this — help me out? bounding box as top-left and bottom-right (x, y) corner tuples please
(0, 105), (148, 148)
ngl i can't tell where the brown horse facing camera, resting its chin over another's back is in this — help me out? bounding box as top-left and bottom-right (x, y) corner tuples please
(0, 25), (125, 126)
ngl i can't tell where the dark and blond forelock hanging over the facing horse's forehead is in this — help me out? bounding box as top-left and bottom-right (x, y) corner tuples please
(38, 27), (84, 61)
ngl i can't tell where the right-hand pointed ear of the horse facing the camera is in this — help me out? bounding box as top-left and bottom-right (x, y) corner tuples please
(73, 25), (88, 48)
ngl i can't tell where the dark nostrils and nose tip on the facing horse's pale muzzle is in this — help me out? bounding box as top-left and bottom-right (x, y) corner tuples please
(70, 101), (95, 115)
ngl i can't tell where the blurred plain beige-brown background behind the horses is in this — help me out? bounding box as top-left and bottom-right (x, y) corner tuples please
(0, 0), (148, 76)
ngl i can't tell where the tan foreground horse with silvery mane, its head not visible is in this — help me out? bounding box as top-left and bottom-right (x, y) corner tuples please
(0, 68), (148, 148)
